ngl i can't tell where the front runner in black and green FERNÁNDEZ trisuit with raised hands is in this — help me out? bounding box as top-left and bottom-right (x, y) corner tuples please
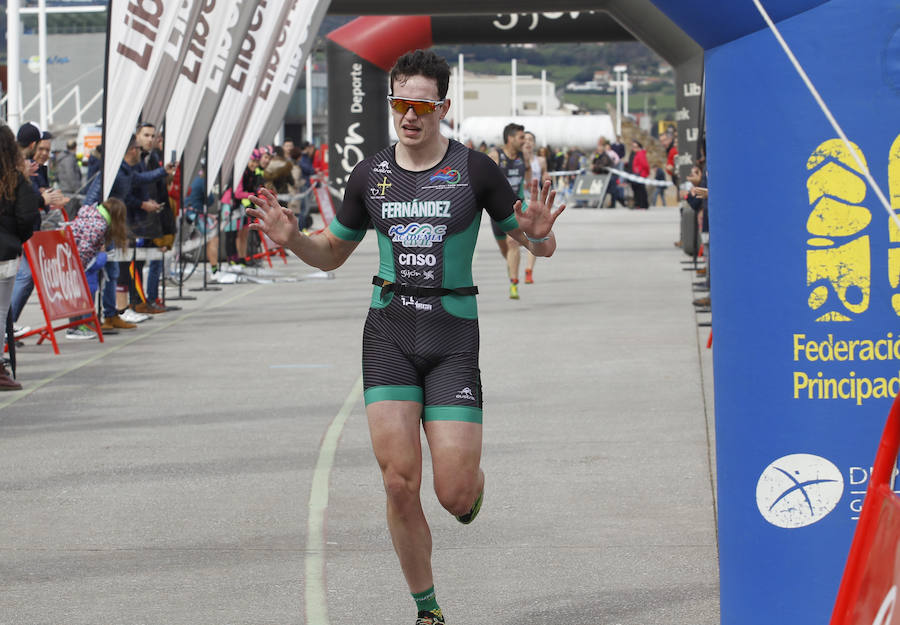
(248, 50), (564, 625)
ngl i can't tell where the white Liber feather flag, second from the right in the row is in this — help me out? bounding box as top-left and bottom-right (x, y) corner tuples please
(207, 0), (291, 188)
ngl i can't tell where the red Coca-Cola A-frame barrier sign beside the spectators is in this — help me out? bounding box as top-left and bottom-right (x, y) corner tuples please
(22, 228), (103, 354)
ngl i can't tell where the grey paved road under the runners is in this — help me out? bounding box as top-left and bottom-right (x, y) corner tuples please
(0, 208), (719, 625)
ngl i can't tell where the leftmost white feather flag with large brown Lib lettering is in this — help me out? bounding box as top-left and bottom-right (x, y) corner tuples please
(103, 0), (181, 198)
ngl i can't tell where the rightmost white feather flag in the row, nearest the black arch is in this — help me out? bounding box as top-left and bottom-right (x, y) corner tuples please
(228, 0), (329, 187)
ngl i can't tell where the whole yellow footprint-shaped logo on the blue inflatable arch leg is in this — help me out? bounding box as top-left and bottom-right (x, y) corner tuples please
(806, 139), (868, 321)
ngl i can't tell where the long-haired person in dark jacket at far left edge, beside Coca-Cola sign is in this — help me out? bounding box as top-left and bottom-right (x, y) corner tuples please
(0, 126), (41, 391)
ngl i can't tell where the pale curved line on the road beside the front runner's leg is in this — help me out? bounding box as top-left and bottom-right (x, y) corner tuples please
(304, 376), (362, 625)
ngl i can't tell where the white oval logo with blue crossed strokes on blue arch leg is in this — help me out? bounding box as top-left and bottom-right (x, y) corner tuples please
(756, 454), (844, 529)
